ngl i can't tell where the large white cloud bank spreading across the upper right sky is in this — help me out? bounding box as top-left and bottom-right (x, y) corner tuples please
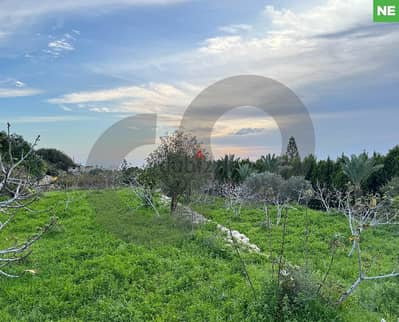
(93, 0), (399, 95)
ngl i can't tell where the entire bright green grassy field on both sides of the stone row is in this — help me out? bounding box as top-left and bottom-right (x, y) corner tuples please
(0, 190), (399, 322)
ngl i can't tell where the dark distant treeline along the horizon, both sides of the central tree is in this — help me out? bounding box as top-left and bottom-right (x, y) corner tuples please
(0, 132), (399, 193)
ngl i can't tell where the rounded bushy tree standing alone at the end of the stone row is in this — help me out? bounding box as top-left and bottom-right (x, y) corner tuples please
(147, 131), (209, 212)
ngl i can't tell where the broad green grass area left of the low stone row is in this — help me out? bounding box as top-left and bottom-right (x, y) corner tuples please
(0, 191), (256, 321)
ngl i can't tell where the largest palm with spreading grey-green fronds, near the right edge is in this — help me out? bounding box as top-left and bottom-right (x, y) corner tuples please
(342, 153), (383, 193)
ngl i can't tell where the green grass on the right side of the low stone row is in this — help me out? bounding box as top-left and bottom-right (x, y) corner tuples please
(193, 199), (399, 321)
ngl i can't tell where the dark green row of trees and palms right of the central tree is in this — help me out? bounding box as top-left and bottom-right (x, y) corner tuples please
(215, 138), (399, 193)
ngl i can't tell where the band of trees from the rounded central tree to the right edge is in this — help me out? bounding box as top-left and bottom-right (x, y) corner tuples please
(138, 131), (399, 211)
